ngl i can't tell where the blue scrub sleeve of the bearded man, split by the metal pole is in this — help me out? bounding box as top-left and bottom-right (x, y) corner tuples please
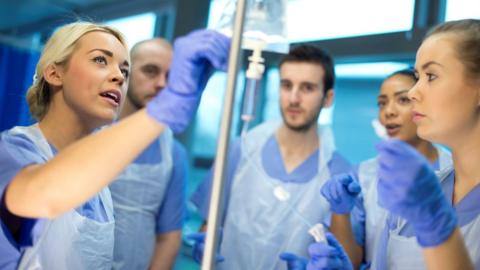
(190, 138), (241, 221)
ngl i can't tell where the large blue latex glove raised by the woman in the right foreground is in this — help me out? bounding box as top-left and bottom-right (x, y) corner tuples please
(377, 139), (457, 247)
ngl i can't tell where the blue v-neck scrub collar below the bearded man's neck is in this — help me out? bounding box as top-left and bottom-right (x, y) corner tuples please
(262, 134), (319, 183)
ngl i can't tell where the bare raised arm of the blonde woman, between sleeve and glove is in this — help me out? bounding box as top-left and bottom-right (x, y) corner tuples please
(5, 110), (164, 218)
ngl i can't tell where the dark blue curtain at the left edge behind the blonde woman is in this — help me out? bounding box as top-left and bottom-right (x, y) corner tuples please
(0, 44), (40, 131)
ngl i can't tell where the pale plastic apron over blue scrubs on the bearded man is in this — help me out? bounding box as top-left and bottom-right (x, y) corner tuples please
(194, 122), (351, 270)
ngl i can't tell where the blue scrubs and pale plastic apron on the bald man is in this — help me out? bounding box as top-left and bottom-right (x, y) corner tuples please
(110, 138), (187, 269)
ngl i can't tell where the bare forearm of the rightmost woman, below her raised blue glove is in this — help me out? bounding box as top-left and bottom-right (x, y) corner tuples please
(423, 228), (474, 270)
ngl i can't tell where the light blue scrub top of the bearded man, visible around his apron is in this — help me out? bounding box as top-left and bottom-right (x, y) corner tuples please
(191, 135), (352, 223)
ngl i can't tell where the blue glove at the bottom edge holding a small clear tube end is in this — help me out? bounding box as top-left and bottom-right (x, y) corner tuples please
(307, 232), (353, 270)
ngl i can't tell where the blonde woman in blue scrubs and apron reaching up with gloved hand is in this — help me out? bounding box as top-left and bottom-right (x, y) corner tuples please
(0, 22), (229, 270)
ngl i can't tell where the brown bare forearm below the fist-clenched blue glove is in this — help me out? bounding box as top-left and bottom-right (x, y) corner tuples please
(330, 213), (363, 269)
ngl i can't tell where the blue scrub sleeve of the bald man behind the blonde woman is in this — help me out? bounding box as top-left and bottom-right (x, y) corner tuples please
(156, 141), (187, 234)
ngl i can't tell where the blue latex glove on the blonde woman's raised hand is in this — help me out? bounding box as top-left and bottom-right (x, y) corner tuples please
(147, 30), (230, 133)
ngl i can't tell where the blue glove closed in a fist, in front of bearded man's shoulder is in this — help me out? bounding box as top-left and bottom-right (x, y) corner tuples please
(320, 173), (361, 214)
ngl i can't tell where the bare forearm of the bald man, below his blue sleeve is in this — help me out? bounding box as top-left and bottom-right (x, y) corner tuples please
(150, 230), (182, 270)
